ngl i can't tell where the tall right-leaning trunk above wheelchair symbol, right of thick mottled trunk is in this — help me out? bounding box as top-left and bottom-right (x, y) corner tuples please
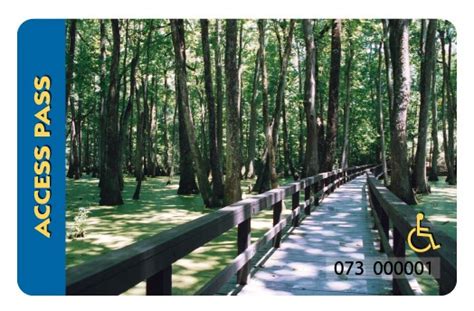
(414, 20), (436, 193)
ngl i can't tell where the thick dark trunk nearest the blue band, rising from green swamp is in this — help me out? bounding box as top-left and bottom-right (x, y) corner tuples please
(99, 19), (123, 205)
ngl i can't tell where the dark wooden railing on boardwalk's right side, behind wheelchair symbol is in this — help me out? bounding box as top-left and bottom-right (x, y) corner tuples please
(367, 172), (456, 295)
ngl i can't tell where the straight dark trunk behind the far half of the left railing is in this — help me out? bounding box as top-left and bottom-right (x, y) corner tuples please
(323, 19), (342, 171)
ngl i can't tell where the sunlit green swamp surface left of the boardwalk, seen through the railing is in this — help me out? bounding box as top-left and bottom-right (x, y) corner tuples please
(66, 177), (291, 295)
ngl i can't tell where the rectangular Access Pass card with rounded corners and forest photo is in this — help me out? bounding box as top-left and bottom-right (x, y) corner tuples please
(18, 19), (457, 296)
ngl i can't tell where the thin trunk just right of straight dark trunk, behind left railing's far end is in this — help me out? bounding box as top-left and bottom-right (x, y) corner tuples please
(341, 33), (354, 168)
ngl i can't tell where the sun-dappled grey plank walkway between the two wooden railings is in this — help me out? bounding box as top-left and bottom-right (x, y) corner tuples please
(232, 175), (392, 295)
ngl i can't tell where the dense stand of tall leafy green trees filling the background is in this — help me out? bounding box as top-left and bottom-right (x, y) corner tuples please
(66, 19), (457, 219)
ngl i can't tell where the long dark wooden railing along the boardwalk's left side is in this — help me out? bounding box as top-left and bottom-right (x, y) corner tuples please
(66, 165), (373, 295)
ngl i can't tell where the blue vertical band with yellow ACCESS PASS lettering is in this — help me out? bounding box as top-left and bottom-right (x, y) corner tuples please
(18, 20), (66, 295)
